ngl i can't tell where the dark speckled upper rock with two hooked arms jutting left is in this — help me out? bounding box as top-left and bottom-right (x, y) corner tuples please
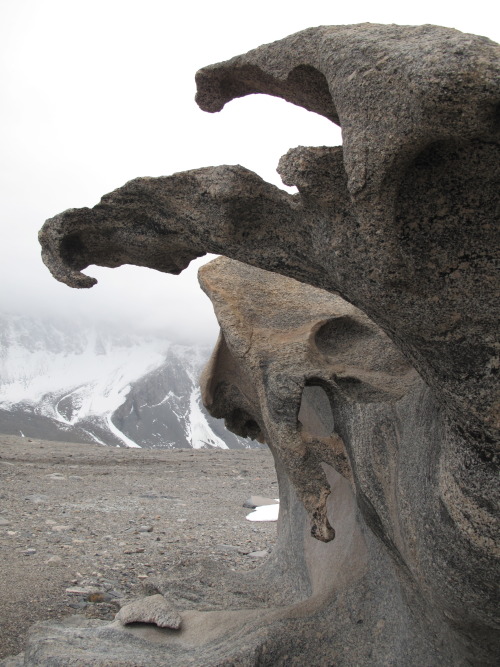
(40, 24), (500, 451)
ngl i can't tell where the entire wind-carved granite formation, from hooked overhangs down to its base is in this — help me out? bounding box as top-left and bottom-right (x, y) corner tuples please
(32, 24), (500, 666)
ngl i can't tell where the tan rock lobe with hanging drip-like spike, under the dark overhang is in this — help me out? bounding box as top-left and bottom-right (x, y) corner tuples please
(200, 260), (417, 542)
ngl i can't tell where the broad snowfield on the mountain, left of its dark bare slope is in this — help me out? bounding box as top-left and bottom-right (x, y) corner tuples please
(0, 320), (171, 438)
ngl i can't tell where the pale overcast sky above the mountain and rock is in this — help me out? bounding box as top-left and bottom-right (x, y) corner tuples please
(0, 0), (500, 342)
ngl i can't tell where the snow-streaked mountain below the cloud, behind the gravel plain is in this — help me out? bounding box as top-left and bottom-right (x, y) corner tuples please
(0, 316), (252, 448)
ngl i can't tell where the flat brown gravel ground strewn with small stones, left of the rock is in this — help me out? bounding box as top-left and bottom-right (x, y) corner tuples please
(0, 435), (278, 659)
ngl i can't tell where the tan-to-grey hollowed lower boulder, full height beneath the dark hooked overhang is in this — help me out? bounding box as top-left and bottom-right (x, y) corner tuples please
(200, 258), (499, 665)
